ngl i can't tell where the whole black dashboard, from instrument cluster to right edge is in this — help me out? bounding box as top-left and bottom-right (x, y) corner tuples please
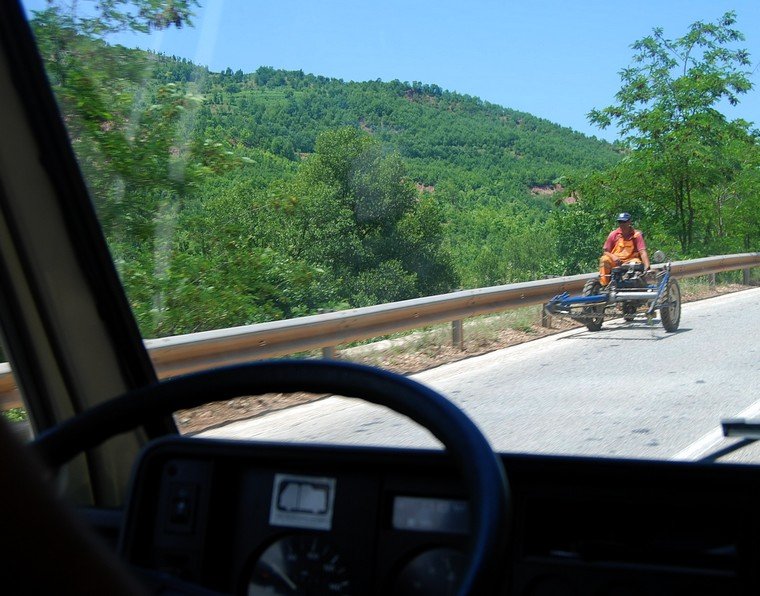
(120, 438), (760, 596)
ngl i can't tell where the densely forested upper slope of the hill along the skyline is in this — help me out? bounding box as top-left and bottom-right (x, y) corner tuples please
(156, 56), (619, 206)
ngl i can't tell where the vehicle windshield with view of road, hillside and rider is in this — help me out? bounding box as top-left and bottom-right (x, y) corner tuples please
(10, 0), (760, 462)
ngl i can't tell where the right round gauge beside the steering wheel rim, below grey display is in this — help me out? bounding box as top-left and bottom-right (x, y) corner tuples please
(394, 547), (467, 596)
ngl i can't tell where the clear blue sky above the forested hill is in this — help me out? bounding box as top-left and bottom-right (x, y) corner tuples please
(20, 0), (760, 140)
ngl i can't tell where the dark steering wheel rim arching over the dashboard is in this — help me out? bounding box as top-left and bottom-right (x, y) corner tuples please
(33, 360), (509, 594)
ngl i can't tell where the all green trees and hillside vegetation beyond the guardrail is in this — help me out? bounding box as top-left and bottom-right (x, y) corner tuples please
(22, 0), (760, 344)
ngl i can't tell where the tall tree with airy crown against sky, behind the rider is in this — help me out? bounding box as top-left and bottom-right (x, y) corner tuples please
(588, 12), (752, 253)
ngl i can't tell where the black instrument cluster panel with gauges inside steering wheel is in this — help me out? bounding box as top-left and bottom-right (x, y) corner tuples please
(122, 439), (469, 594)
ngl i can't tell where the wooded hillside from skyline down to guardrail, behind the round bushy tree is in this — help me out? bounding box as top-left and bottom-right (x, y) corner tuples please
(155, 56), (622, 290)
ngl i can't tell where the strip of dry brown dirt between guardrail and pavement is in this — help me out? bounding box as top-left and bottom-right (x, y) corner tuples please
(175, 284), (748, 434)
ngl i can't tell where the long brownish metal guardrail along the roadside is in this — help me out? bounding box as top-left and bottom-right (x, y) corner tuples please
(0, 253), (760, 409)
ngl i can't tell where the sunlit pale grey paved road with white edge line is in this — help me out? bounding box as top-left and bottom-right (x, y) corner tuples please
(204, 288), (760, 462)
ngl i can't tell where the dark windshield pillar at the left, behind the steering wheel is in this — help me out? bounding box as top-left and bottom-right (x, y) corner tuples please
(0, 0), (177, 507)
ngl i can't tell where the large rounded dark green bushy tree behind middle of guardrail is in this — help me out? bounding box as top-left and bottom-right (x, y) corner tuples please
(282, 127), (456, 306)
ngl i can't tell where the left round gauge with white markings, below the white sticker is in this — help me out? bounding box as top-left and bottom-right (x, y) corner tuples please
(248, 534), (351, 596)
